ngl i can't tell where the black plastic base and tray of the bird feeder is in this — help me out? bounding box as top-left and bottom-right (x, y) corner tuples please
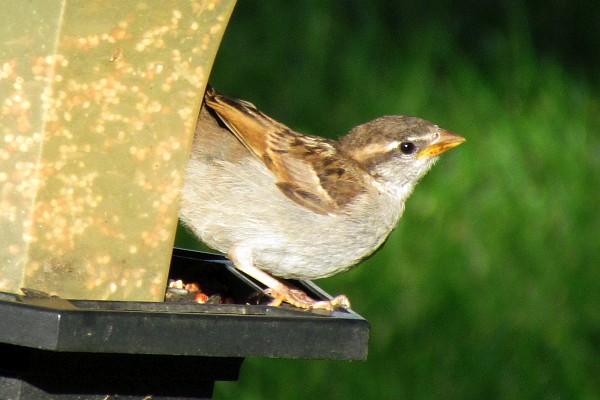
(0, 249), (369, 400)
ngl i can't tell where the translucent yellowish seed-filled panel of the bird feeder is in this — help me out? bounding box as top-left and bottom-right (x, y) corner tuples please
(0, 0), (235, 301)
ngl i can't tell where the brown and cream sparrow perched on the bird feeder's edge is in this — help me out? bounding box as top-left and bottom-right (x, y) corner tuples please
(180, 87), (465, 310)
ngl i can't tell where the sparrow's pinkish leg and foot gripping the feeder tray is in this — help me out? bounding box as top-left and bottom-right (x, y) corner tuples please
(228, 246), (350, 311)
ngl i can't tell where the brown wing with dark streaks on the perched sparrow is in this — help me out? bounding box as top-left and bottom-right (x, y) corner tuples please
(205, 88), (368, 214)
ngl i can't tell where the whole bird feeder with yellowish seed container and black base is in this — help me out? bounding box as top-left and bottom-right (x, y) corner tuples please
(0, 0), (369, 400)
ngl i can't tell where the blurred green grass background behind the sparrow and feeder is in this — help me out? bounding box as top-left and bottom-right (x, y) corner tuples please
(180, 0), (600, 400)
